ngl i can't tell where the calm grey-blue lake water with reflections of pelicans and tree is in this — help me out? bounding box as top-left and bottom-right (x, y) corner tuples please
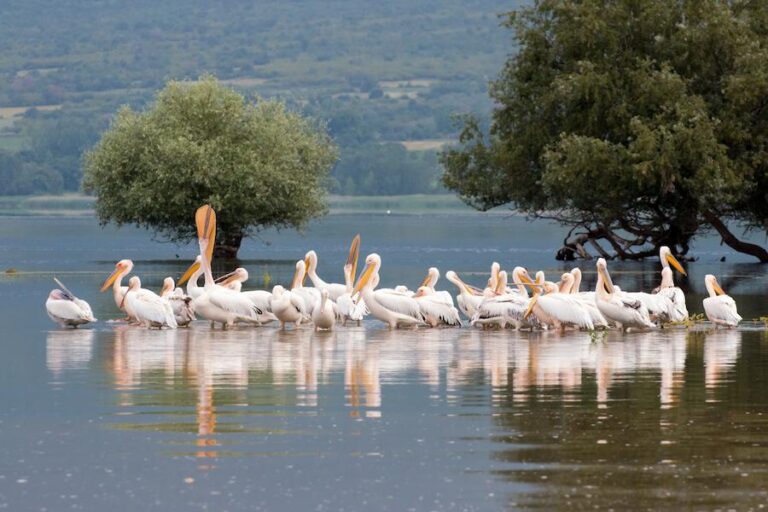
(0, 214), (768, 511)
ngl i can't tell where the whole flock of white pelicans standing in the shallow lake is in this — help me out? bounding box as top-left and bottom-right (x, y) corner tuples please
(46, 205), (741, 330)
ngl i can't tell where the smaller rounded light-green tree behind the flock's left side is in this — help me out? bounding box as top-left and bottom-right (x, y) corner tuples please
(83, 76), (336, 257)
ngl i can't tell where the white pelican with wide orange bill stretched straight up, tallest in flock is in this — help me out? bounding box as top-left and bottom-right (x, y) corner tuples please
(192, 205), (262, 329)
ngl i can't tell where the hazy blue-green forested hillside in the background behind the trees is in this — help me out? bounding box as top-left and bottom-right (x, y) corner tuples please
(0, 0), (519, 194)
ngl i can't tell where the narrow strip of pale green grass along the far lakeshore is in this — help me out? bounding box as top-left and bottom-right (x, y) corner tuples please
(0, 194), (480, 216)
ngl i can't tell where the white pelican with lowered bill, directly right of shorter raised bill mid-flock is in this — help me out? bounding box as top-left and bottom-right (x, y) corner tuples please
(352, 253), (424, 329)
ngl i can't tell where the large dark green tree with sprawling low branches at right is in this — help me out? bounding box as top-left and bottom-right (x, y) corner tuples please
(441, 0), (768, 262)
